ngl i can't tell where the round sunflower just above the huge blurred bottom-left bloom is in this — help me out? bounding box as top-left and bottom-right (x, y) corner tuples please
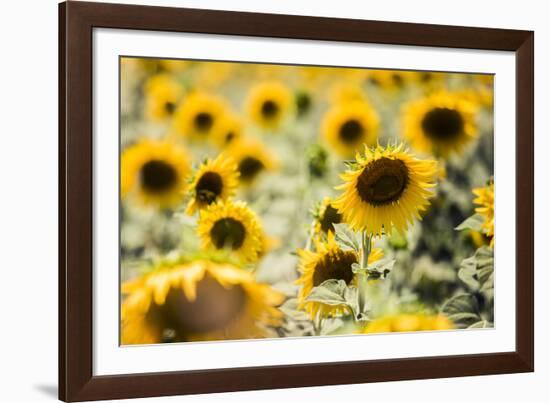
(197, 201), (264, 263)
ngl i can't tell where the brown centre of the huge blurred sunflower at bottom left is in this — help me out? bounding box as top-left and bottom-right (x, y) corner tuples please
(146, 275), (246, 342)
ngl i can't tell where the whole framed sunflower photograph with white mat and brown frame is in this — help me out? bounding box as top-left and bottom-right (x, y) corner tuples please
(59, 2), (534, 401)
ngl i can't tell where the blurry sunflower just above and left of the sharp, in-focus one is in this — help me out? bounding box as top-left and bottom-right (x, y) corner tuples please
(321, 102), (380, 158)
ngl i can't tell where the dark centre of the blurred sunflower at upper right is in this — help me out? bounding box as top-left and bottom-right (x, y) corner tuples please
(422, 108), (464, 141)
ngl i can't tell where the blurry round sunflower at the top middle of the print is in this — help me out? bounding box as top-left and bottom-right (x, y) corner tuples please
(246, 81), (294, 130)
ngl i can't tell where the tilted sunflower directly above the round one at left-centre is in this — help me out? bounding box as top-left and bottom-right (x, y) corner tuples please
(186, 154), (239, 215)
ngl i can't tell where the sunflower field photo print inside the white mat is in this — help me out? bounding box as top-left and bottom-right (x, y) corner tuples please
(119, 57), (494, 344)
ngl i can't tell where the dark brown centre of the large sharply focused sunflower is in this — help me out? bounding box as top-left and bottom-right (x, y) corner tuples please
(356, 157), (409, 206)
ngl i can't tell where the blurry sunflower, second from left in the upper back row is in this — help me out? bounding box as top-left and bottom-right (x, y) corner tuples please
(174, 92), (227, 141)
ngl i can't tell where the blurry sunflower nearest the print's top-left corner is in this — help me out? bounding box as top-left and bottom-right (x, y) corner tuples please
(145, 74), (184, 121)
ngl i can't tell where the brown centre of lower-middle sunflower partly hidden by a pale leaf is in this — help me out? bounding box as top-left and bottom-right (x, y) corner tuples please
(313, 250), (357, 287)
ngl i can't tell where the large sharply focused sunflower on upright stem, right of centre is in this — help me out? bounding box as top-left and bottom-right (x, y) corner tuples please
(333, 144), (438, 235)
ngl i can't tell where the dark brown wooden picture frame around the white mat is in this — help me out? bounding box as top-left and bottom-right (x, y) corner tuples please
(59, 2), (534, 401)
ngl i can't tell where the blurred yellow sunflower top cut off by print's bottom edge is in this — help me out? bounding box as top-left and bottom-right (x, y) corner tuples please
(360, 313), (455, 333)
